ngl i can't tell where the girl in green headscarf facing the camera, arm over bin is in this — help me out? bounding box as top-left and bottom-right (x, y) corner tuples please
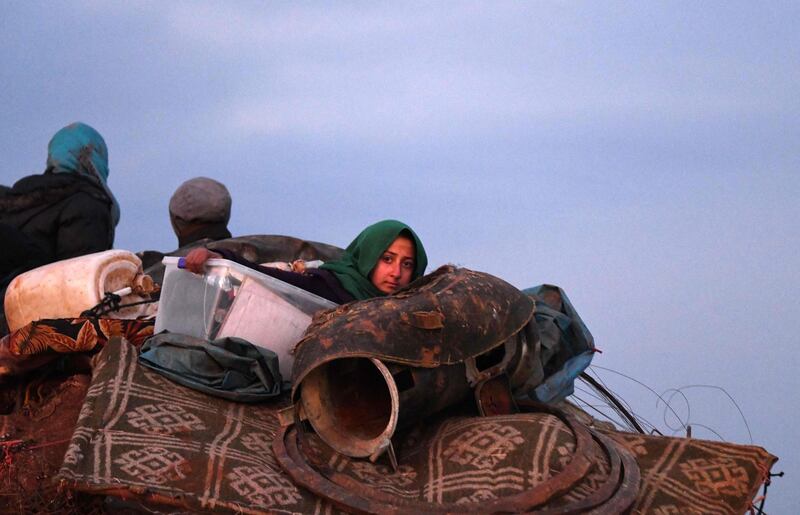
(185, 220), (428, 304)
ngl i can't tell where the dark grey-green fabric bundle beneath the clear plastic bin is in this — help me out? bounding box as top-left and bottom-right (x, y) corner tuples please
(139, 331), (281, 402)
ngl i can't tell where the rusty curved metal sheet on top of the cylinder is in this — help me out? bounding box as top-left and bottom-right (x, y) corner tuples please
(292, 265), (534, 389)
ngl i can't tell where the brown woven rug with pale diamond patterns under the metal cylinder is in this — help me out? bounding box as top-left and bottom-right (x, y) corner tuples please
(59, 339), (776, 514)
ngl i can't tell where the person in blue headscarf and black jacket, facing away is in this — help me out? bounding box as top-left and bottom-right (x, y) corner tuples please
(0, 123), (119, 279)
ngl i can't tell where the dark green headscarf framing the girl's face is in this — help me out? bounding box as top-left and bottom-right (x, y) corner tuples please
(320, 220), (428, 300)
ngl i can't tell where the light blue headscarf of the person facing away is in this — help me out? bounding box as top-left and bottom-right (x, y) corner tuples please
(47, 122), (119, 226)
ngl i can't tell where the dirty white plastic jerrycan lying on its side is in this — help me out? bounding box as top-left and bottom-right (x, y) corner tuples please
(5, 250), (153, 332)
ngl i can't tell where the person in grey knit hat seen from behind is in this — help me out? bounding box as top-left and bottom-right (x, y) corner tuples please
(169, 177), (231, 247)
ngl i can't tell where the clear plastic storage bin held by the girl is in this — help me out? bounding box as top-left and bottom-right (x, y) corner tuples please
(155, 257), (336, 380)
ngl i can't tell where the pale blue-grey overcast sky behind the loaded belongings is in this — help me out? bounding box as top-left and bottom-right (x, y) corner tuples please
(0, 0), (800, 513)
